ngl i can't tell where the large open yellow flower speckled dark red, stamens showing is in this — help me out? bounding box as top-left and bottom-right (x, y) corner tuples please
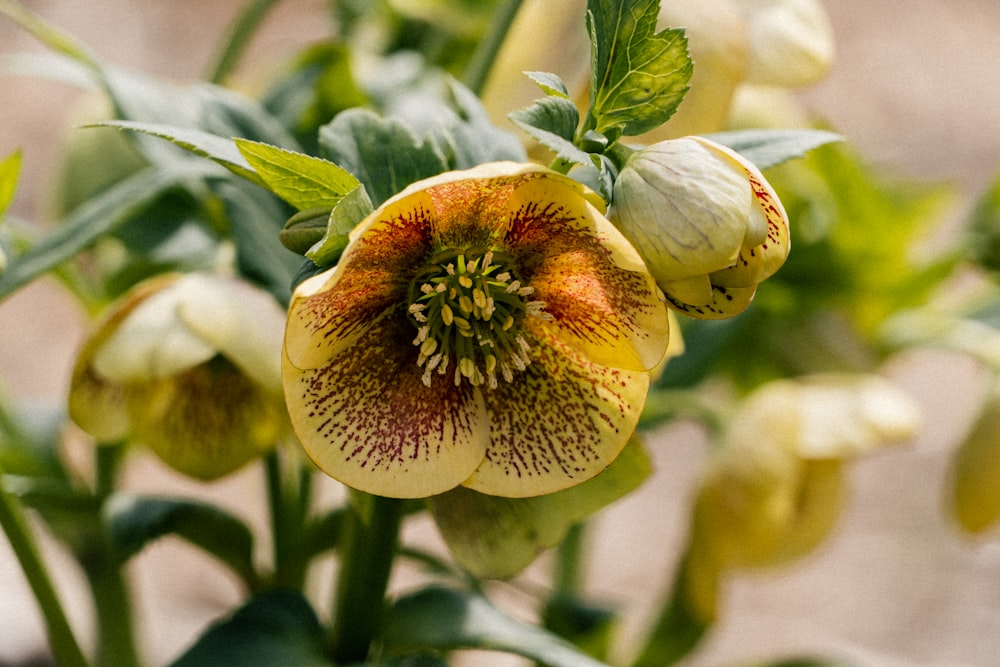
(282, 162), (668, 497)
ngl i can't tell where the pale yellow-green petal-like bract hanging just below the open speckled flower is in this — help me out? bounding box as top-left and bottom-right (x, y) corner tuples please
(430, 440), (650, 579)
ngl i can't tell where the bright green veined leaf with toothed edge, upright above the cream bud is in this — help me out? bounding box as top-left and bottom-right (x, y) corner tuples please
(584, 0), (693, 139)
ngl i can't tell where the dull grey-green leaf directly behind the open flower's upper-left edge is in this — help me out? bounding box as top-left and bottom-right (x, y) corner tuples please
(320, 109), (449, 206)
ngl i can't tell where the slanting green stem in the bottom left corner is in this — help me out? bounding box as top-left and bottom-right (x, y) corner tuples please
(0, 471), (87, 667)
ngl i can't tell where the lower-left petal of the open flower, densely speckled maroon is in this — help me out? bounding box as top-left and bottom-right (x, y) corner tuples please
(282, 312), (488, 498)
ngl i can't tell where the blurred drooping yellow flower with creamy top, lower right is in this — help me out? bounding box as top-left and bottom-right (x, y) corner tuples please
(687, 374), (920, 618)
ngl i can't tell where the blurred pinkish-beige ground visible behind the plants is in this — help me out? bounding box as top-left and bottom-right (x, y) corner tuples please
(0, 0), (1000, 667)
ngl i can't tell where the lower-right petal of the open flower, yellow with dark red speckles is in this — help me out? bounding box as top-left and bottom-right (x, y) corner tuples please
(463, 330), (649, 498)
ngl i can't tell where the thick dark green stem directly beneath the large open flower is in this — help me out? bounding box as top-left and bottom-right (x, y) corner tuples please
(330, 494), (404, 664)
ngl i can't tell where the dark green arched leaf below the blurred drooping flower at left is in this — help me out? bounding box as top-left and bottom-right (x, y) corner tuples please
(104, 493), (256, 585)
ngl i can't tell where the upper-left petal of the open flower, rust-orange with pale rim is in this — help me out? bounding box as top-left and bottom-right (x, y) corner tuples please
(285, 192), (432, 368)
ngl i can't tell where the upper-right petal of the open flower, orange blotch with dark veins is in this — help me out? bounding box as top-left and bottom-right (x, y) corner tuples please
(503, 175), (670, 370)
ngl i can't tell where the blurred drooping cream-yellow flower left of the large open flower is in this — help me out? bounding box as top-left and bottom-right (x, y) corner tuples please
(69, 273), (288, 480)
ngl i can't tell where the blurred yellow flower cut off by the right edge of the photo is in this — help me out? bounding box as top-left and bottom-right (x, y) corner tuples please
(952, 387), (1000, 533)
